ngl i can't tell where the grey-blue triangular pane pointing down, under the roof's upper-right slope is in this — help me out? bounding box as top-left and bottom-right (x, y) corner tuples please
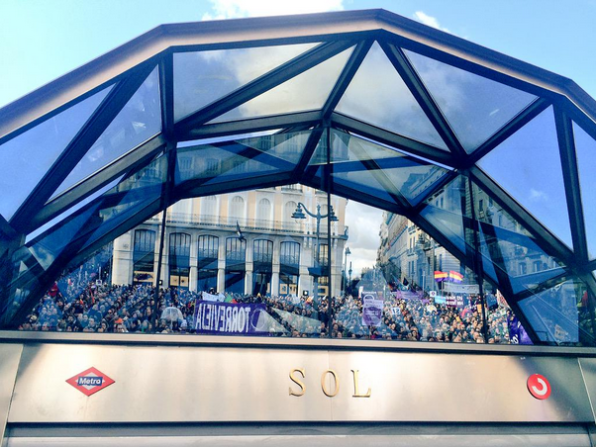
(404, 50), (536, 153)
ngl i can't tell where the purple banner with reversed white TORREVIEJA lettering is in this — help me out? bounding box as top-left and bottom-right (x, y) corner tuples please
(195, 301), (268, 335)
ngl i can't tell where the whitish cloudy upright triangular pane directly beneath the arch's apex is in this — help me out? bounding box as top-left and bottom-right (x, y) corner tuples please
(336, 42), (447, 150)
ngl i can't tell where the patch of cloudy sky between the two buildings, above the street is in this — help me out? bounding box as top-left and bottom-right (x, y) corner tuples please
(346, 200), (383, 278)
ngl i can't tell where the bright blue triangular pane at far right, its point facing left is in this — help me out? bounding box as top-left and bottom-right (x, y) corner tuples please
(478, 107), (572, 247)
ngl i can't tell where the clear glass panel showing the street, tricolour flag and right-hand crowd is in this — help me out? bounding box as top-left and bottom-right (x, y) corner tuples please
(332, 201), (507, 343)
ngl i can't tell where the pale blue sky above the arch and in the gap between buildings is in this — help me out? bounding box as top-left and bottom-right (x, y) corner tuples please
(0, 0), (596, 274)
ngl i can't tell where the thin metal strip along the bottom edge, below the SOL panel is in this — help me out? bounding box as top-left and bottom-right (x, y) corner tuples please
(7, 434), (590, 447)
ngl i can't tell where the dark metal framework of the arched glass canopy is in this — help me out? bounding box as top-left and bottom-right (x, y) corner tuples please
(0, 10), (596, 345)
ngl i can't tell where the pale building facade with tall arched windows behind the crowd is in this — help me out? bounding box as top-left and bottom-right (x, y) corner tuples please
(112, 185), (347, 295)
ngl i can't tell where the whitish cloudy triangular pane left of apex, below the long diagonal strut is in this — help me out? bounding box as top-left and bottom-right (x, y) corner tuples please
(210, 47), (354, 123)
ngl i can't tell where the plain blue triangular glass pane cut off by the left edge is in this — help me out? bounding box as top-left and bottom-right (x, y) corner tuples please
(0, 87), (112, 220)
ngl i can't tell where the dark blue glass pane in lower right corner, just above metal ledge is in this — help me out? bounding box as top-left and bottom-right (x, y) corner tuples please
(519, 278), (595, 346)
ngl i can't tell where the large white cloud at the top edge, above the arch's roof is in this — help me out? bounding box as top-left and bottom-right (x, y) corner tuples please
(203, 0), (344, 20)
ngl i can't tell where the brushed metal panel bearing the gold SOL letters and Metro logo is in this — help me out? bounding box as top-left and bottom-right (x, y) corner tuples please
(9, 344), (594, 423)
